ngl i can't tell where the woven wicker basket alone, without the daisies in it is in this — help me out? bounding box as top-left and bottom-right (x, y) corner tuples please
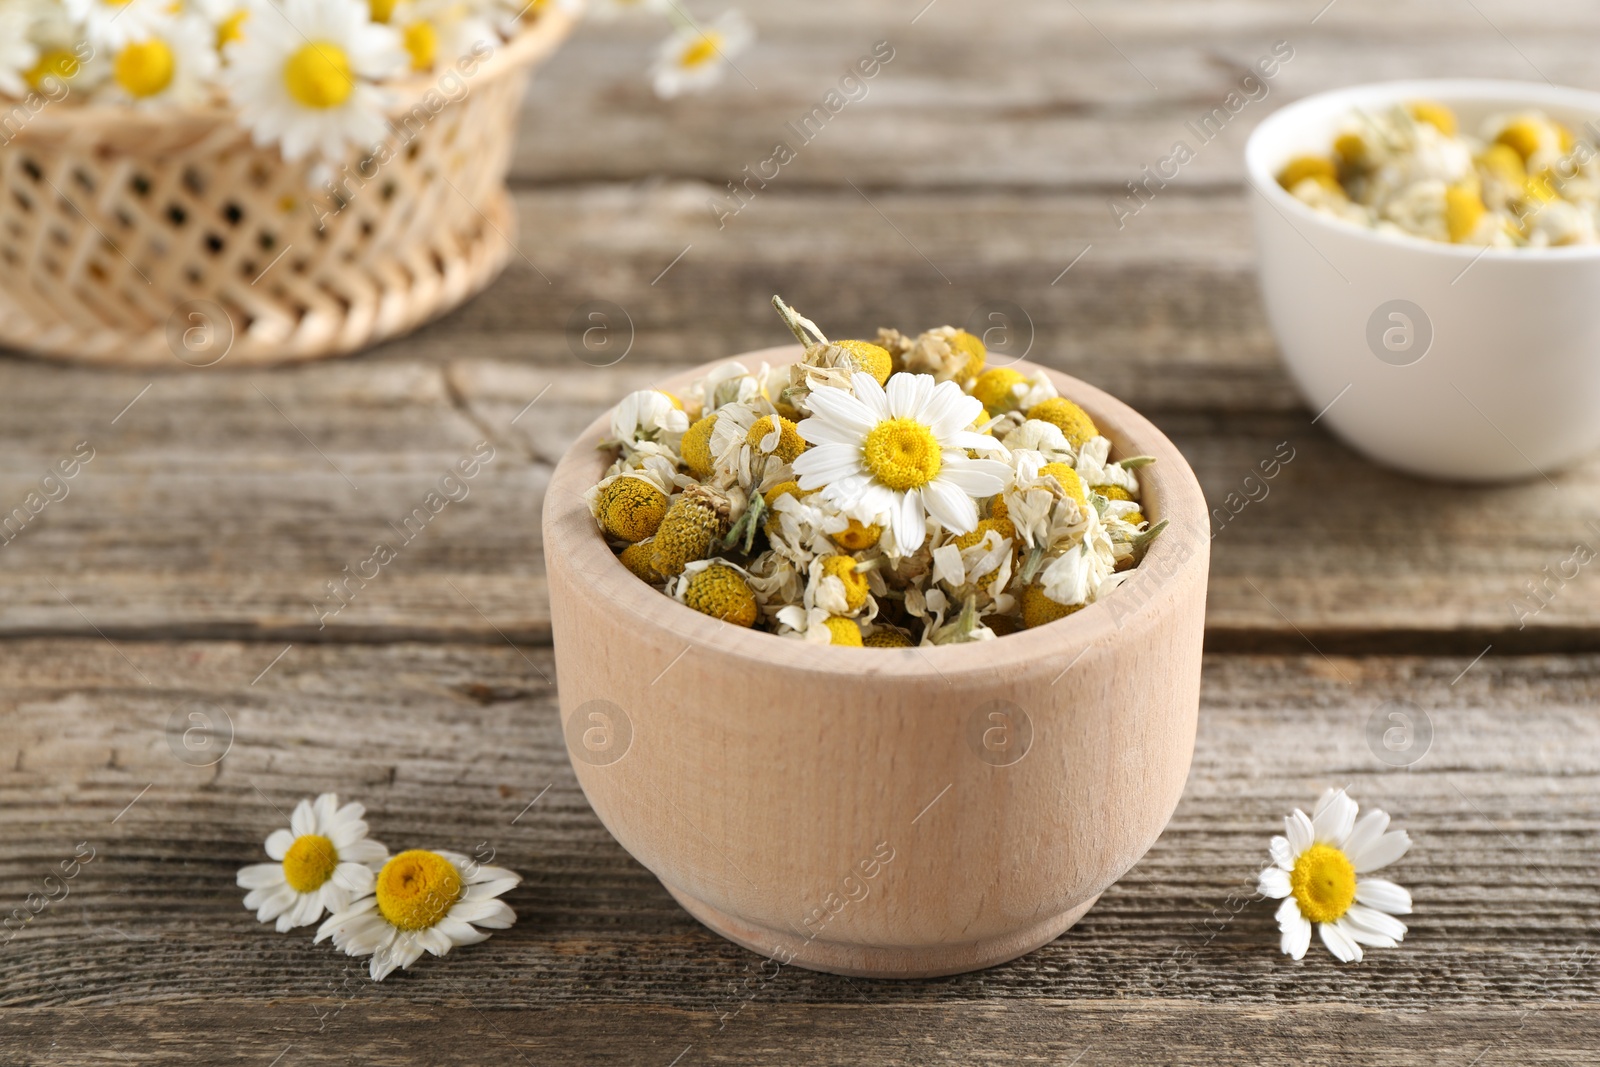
(0, 10), (571, 370)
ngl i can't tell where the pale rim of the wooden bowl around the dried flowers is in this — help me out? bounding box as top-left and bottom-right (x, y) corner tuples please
(544, 344), (1210, 680)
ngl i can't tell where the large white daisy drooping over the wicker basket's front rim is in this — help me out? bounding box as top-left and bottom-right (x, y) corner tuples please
(224, 0), (406, 162)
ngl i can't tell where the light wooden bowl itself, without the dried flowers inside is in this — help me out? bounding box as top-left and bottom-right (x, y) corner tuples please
(544, 346), (1210, 977)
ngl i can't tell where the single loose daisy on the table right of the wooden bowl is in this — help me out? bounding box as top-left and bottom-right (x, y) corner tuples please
(1259, 789), (1411, 963)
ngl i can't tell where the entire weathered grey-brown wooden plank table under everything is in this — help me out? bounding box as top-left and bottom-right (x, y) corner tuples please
(0, 0), (1600, 1067)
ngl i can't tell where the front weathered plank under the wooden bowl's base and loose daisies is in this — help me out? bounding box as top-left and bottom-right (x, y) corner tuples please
(0, 638), (1600, 1062)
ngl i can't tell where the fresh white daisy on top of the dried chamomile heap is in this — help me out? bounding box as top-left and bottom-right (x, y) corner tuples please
(794, 371), (1011, 553)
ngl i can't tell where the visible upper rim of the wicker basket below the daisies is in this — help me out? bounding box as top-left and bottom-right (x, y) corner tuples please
(0, 8), (578, 139)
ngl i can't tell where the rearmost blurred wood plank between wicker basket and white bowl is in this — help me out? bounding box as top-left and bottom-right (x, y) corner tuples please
(514, 0), (1600, 189)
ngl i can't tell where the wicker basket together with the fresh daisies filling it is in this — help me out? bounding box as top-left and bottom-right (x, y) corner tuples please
(0, 0), (573, 366)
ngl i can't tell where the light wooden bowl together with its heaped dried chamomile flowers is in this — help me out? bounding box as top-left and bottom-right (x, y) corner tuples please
(544, 302), (1210, 977)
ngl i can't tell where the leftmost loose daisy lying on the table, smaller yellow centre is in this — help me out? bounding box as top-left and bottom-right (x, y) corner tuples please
(238, 793), (389, 934)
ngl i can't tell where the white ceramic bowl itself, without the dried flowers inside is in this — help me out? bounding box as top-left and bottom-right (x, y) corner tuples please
(1245, 80), (1600, 482)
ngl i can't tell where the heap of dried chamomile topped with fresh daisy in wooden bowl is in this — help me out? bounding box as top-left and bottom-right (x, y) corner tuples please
(589, 298), (1165, 648)
